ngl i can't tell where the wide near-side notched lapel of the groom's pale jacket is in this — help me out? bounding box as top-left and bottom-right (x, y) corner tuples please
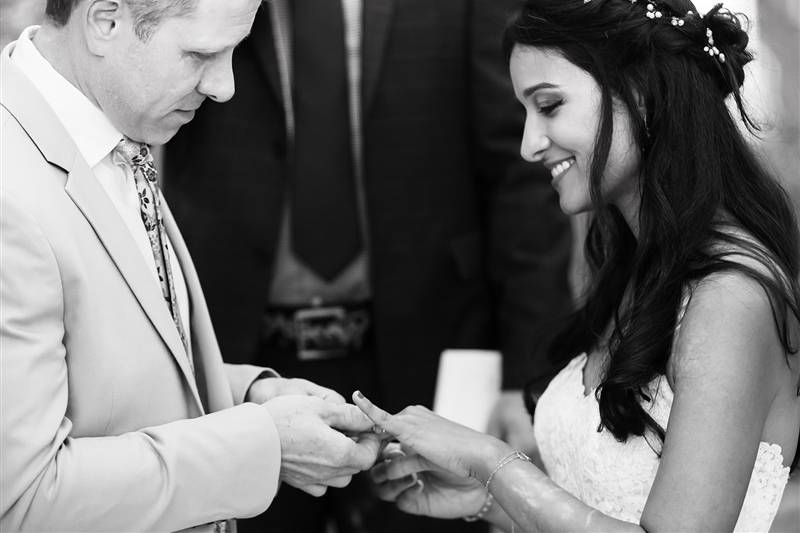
(0, 50), (200, 412)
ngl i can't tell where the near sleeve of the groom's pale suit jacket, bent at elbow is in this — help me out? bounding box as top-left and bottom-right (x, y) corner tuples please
(0, 194), (280, 531)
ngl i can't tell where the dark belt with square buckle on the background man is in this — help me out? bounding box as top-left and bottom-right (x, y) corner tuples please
(261, 302), (372, 361)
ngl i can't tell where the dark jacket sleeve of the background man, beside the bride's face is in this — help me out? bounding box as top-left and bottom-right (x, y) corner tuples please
(470, 0), (571, 389)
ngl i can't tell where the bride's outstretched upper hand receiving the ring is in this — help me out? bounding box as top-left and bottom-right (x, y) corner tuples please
(353, 391), (512, 483)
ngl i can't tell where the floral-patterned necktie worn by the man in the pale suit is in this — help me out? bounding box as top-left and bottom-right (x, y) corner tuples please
(117, 139), (189, 353)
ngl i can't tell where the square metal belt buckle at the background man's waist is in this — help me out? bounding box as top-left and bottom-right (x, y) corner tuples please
(294, 307), (350, 361)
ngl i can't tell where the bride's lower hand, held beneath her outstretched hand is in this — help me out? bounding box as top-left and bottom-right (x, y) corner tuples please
(370, 448), (486, 519)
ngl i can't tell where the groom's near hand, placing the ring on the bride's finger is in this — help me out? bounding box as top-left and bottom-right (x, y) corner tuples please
(264, 395), (381, 496)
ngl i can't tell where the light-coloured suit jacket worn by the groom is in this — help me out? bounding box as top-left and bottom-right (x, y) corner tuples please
(0, 45), (280, 531)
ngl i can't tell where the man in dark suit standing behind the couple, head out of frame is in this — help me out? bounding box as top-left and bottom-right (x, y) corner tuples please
(165, 0), (570, 533)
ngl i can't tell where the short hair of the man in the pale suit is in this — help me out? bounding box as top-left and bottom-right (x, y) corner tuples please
(45, 0), (196, 41)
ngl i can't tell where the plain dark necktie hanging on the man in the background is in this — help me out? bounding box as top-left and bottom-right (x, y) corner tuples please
(291, 0), (362, 281)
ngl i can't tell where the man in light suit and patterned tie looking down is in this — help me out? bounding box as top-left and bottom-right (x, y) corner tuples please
(0, 0), (379, 531)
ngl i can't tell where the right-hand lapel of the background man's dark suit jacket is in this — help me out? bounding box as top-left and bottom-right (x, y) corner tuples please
(361, 0), (395, 111)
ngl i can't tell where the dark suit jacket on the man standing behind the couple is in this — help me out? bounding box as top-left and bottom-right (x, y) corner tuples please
(165, 0), (569, 410)
